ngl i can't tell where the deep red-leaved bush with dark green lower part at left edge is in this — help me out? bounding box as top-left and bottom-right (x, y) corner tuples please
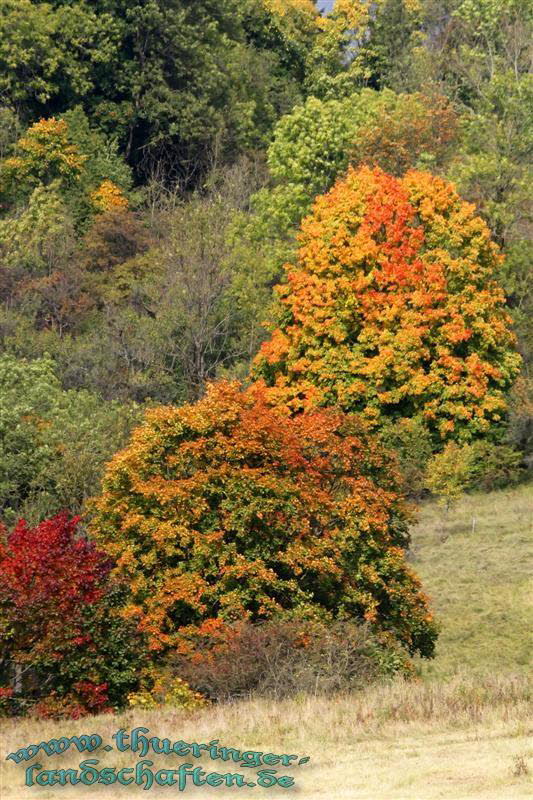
(0, 513), (143, 716)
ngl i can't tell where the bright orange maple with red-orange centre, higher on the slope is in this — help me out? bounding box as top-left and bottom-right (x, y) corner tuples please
(252, 166), (520, 440)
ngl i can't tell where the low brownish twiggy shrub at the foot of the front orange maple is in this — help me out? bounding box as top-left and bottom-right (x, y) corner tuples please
(167, 619), (409, 700)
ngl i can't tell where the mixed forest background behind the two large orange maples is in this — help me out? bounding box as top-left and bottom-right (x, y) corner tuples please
(0, 0), (532, 524)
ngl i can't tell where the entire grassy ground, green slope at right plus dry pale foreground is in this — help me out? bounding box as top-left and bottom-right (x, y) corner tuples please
(0, 487), (533, 800)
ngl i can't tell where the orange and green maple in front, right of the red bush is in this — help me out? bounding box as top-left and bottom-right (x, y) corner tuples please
(92, 383), (436, 656)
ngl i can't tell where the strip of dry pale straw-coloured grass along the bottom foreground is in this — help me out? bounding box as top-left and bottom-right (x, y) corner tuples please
(0, 677), (533, 800)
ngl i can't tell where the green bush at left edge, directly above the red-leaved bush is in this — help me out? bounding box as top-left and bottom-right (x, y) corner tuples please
(0, 354), (136, 525)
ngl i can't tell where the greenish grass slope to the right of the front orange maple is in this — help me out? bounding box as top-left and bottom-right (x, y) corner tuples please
(411, 485), (533, 677)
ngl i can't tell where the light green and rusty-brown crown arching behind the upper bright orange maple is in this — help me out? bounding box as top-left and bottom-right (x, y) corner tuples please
(249, 88), (458, 268)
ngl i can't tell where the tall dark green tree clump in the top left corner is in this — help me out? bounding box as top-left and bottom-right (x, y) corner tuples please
(0, 0), (319, 184)
